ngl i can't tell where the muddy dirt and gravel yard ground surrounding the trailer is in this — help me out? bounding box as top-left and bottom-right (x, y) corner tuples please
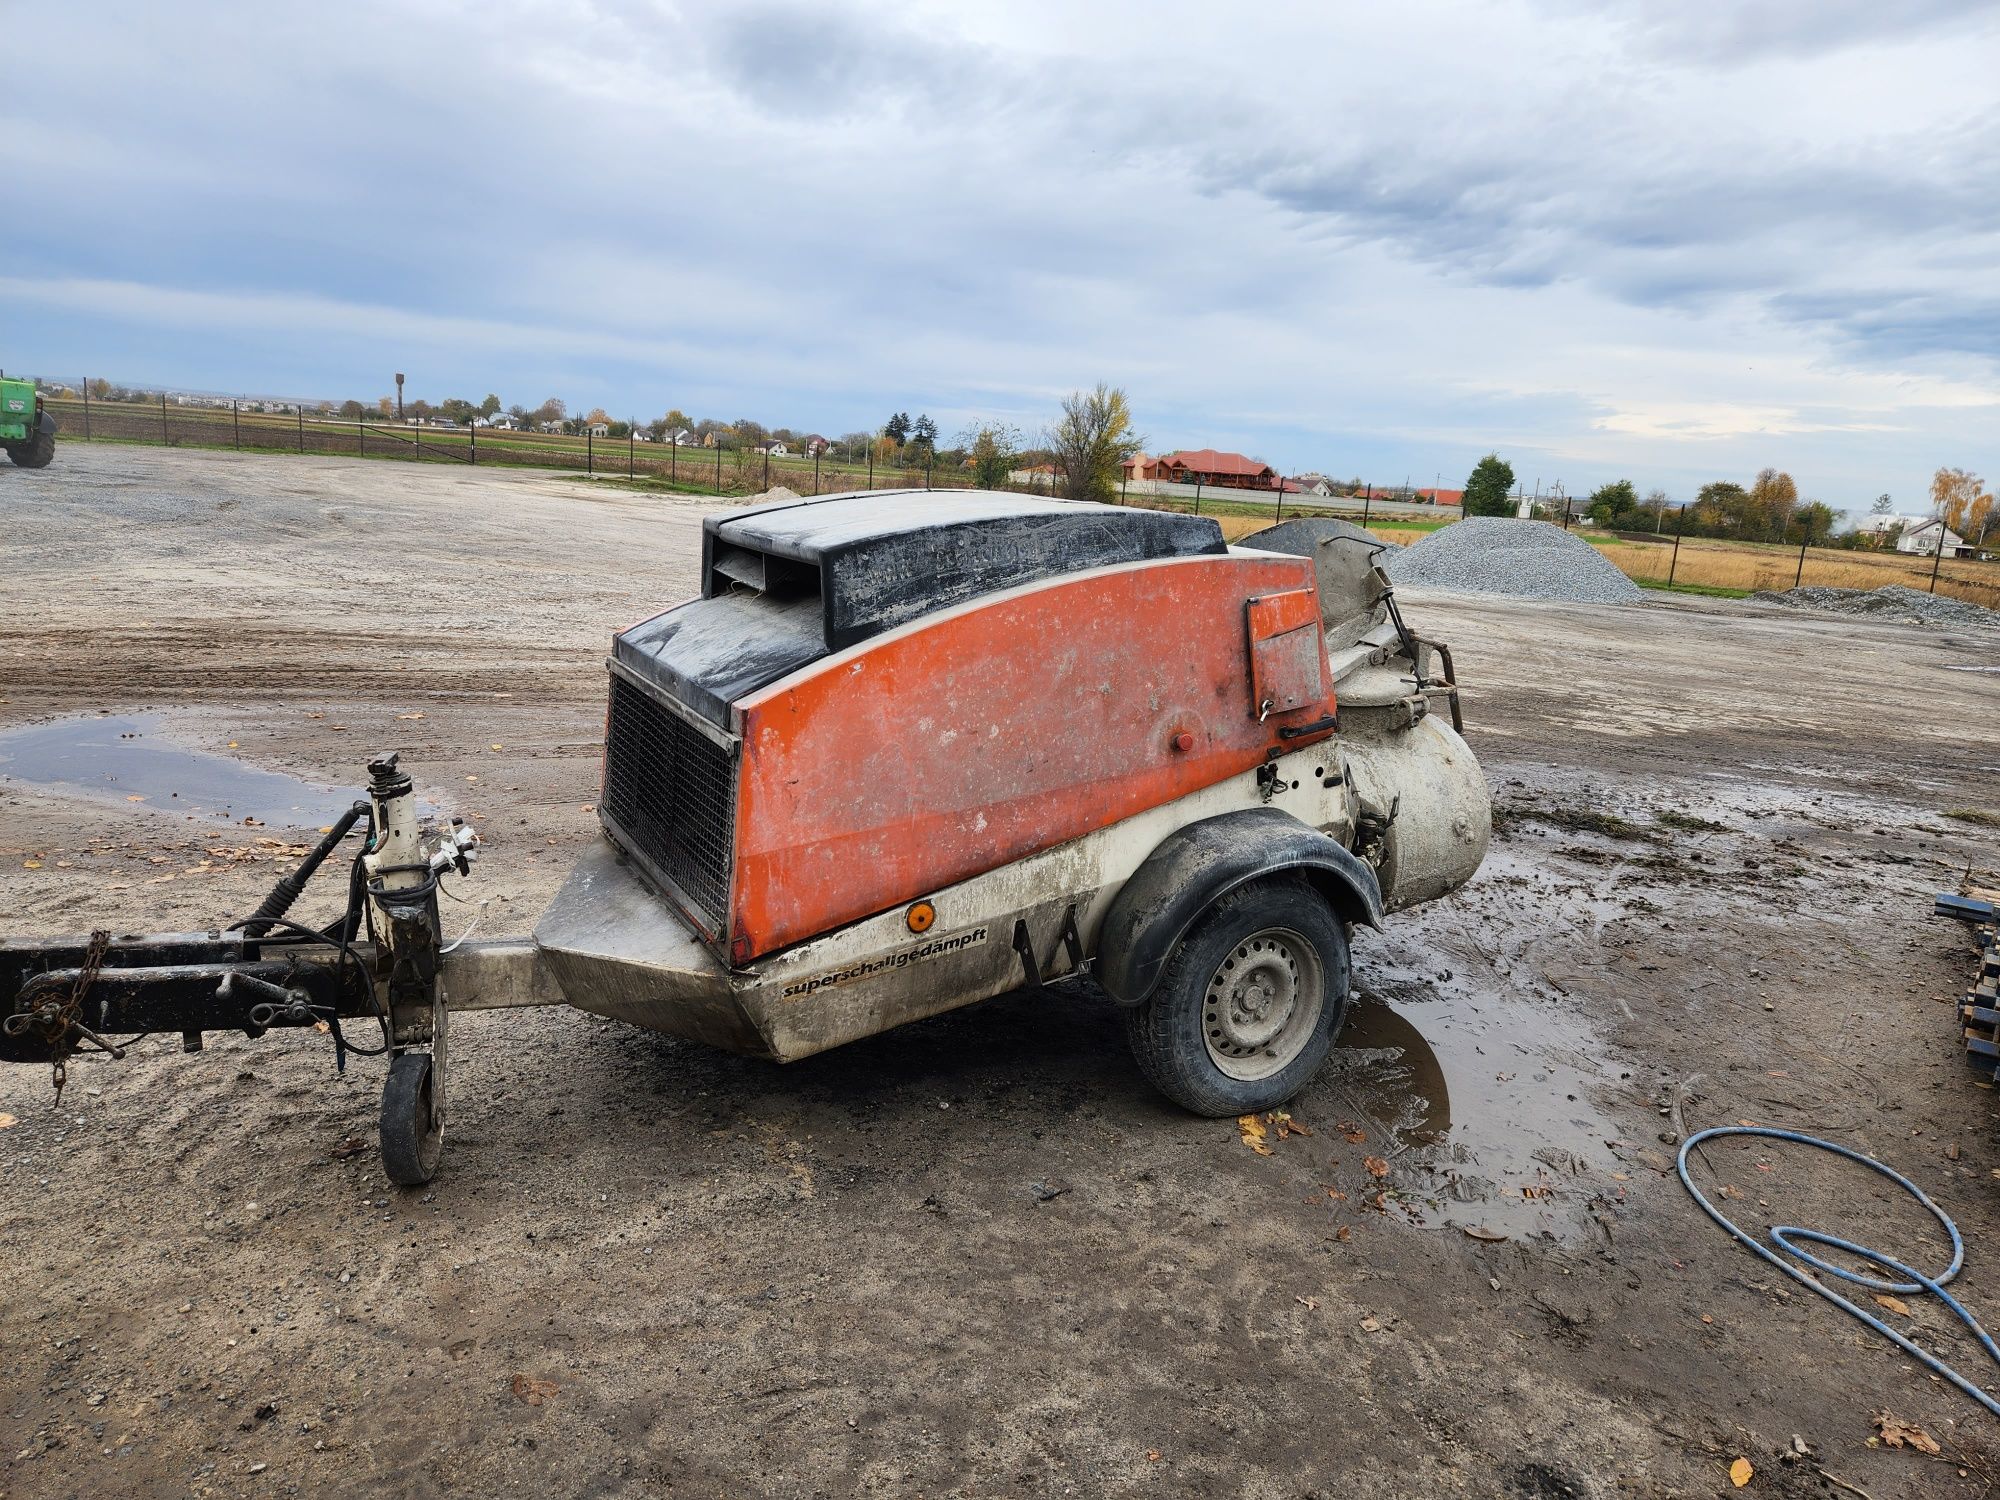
(0, 444), (2000, 1500)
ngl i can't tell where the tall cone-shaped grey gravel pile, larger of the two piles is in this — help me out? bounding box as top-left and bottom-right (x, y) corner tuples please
(1382, 516), (1642, 604)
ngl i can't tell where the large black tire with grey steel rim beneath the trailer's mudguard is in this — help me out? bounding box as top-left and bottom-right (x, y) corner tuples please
(1126, 880), (1348, 1116)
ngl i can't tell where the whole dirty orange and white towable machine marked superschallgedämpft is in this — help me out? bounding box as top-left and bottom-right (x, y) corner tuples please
(0, 490), (1490, 1184)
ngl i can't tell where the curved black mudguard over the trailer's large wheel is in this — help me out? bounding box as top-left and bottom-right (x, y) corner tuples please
(1096, 808), (1382, 1006)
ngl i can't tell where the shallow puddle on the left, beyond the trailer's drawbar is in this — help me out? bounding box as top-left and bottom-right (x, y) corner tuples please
(0, 714), (354, 828)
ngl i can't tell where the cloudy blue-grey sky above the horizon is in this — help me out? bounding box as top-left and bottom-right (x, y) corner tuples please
(0, 0), (2000, 510)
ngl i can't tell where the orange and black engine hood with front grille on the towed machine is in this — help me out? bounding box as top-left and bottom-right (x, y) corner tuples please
(600, 492), (1334, 966)
